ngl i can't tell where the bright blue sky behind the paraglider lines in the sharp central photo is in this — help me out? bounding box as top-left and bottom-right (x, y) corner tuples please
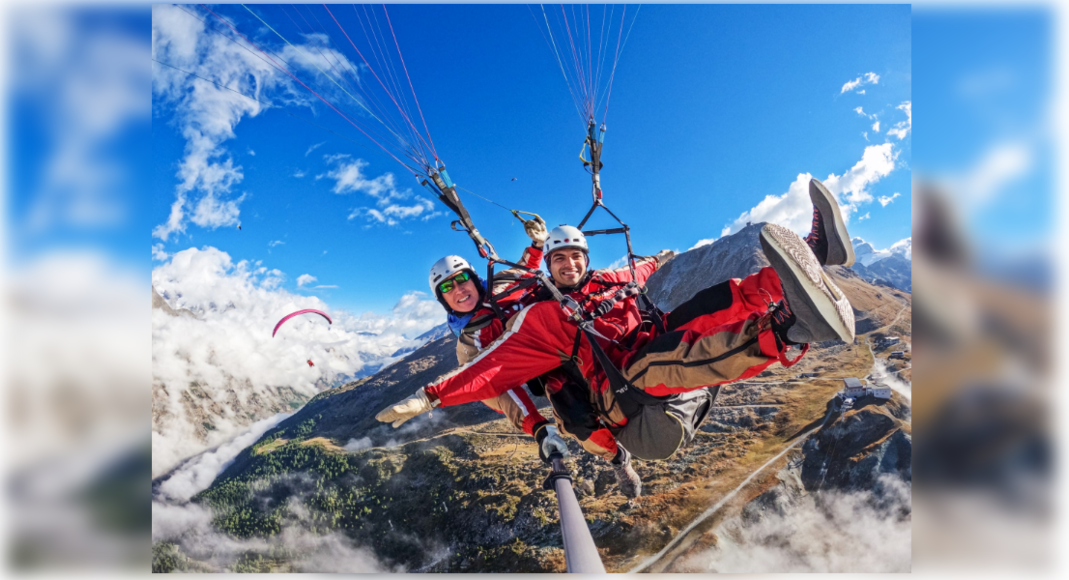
(150, 4), (912, 312)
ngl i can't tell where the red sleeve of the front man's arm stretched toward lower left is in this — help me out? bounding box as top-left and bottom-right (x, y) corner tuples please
(425, 302), (575, 407)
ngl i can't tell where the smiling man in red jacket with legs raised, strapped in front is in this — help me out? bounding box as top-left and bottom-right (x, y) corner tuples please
(376, 179), (854, 458)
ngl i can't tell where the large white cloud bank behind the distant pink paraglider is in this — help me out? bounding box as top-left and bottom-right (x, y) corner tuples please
(152, 247), (445, 476)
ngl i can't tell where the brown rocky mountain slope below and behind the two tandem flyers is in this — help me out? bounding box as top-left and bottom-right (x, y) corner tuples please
(154, 225), (912, 573)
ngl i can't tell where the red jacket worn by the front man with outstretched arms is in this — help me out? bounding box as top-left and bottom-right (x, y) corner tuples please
(425, 257), (660, 406)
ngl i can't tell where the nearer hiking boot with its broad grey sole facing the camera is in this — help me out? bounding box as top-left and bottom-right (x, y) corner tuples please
(760, 223), (854, 344)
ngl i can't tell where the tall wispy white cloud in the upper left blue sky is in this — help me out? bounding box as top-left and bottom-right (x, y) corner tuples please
(152, 4), (344, 241)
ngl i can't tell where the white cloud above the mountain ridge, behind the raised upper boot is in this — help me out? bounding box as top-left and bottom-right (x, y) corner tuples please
(721, 143), (898, 236)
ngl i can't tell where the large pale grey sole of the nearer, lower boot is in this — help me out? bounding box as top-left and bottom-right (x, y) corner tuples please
(761, 223), (854, 343)
